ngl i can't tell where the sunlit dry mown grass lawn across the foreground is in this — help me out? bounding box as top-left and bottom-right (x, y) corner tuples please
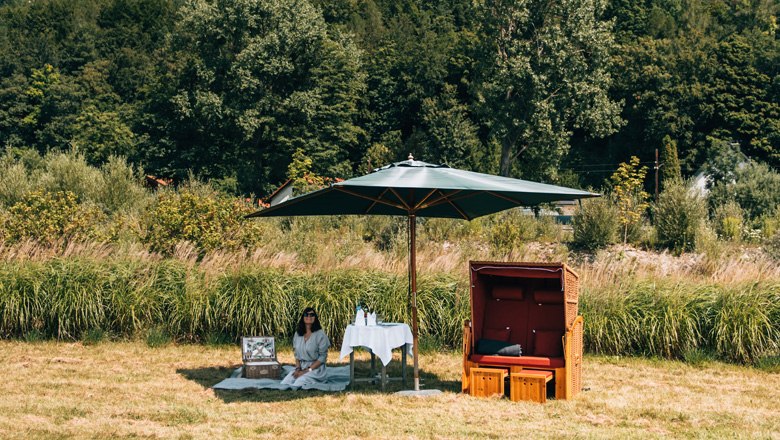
(0, 341), (780, 439)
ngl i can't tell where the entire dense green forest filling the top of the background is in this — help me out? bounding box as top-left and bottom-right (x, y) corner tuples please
(0, 0), (780, 195)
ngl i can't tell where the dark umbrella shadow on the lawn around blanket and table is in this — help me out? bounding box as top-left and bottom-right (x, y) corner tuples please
(176, 360), (461, 403)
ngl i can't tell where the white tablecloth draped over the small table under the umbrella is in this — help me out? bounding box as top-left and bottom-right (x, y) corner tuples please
(341, 323), (414, 365)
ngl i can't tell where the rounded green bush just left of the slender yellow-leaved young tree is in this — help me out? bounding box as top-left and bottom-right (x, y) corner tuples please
(572, 197), (620, 250)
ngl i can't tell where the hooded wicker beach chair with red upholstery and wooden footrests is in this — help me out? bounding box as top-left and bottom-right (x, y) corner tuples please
(462, 262), (583, 402)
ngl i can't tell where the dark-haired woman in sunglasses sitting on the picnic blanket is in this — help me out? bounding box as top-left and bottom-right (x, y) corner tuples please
(282, 307), (330, 389)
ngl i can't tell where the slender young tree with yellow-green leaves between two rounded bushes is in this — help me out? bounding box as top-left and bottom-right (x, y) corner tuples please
(610, 156), (650, 243)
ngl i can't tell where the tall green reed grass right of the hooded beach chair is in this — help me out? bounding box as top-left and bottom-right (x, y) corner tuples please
(581, 280), (780, 363)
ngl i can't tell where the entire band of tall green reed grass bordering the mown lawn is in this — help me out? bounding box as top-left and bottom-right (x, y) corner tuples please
(0, 257), (780, 363)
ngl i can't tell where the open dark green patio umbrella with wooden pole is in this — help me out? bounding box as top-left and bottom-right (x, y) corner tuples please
(247, 155), (599, 391)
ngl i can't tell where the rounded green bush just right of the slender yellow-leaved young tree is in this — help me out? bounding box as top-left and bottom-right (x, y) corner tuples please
(653, 180), (707, 252)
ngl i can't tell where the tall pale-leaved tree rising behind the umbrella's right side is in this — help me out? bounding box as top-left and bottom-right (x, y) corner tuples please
(478, 0), (621, 177)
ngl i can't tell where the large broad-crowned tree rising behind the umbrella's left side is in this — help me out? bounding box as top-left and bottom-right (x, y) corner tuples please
(145, 0), (365, 193)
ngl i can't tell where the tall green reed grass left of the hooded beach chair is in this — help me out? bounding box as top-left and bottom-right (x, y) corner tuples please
(0, 259), (469, 347)
